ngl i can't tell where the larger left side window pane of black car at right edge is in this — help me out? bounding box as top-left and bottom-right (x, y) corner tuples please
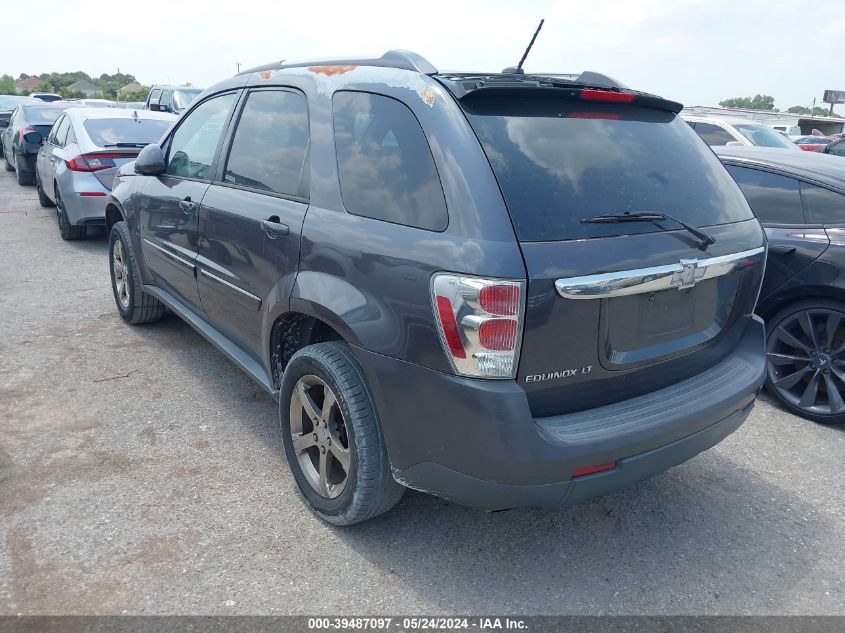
(728, 165), (804, 224)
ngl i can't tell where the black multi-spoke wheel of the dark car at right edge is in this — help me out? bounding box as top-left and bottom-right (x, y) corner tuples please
(767, 308), (845, 415)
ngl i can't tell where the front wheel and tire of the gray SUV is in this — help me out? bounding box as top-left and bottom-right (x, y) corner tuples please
(109, 221), (164, 325)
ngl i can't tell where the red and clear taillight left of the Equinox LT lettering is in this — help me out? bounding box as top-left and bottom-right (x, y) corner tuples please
(431, 273), (525, 378)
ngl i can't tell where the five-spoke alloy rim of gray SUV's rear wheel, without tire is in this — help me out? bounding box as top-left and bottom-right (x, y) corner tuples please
(290, 375), (351, 499)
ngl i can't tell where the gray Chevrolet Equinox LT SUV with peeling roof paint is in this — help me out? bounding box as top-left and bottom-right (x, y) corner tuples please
(107, 51), (766, 525)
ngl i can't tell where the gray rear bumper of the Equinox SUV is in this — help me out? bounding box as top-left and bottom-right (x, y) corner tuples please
(355, 317), (765, 510)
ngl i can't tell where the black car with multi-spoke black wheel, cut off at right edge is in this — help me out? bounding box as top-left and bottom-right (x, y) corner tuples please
(716, 147), (845, 424)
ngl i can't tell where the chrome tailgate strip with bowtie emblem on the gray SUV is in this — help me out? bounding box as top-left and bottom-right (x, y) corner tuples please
(555, 246), (766, 299)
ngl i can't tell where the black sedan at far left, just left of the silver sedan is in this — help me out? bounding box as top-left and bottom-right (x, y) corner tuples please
(0, 102), (71, 185)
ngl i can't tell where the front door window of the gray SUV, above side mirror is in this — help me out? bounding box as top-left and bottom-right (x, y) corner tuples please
(164, 93), (237, 179)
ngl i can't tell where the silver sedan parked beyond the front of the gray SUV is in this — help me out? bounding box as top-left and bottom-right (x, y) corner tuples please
(35, 108), (177, 240)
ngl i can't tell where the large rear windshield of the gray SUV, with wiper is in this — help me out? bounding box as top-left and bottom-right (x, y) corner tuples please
(465, 97), (753, 242)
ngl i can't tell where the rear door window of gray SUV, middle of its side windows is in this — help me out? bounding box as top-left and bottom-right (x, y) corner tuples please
(223, 90), (308, 196)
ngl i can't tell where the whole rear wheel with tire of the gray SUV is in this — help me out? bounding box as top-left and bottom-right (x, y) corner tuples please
(279, 342), (405, 526)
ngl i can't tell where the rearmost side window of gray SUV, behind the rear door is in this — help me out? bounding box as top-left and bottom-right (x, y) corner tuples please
(332, 92), (449, 231)
